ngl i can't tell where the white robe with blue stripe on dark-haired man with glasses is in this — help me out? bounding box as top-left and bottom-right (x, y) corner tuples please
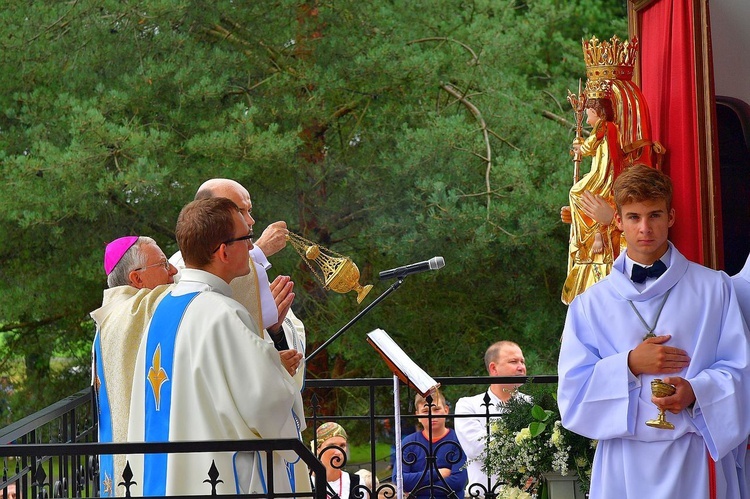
(128, 269), (309, 495)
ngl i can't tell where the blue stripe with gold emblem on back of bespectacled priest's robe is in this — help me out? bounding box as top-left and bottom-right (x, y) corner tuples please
(143, 293), (199, 496)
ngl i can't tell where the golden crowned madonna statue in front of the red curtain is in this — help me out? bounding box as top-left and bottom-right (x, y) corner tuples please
(561, 36), (664, 304)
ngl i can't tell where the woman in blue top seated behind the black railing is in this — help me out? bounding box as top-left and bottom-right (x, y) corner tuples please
(392, 390), (468, 499)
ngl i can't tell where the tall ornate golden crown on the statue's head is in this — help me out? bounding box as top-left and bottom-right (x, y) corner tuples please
(582, 35), (638, 99)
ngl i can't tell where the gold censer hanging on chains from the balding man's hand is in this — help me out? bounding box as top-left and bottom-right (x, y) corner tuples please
(287, 232), (372, 303)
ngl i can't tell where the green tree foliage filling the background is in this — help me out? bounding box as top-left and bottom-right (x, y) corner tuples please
(0, 0), (626, 418)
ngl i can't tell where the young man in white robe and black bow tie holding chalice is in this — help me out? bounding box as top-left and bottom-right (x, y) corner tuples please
(558, 165), (750, 499)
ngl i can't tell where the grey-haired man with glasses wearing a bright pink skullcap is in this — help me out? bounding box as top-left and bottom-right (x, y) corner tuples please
(91, 236), (177, 497)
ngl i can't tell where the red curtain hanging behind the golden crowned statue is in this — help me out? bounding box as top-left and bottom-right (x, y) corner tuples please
(638, 0), (704, 263)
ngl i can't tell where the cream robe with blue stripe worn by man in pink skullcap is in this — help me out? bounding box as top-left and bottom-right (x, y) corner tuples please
(91, 284), (172, 497)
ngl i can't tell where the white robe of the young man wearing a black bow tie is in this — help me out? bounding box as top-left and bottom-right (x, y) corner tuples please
(558, 243), (750, 499)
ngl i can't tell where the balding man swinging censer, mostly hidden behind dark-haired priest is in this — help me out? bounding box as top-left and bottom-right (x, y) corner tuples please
(170, 178), (306, 390)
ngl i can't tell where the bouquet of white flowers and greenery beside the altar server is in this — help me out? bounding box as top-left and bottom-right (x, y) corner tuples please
(479, 394), (596, 498)
